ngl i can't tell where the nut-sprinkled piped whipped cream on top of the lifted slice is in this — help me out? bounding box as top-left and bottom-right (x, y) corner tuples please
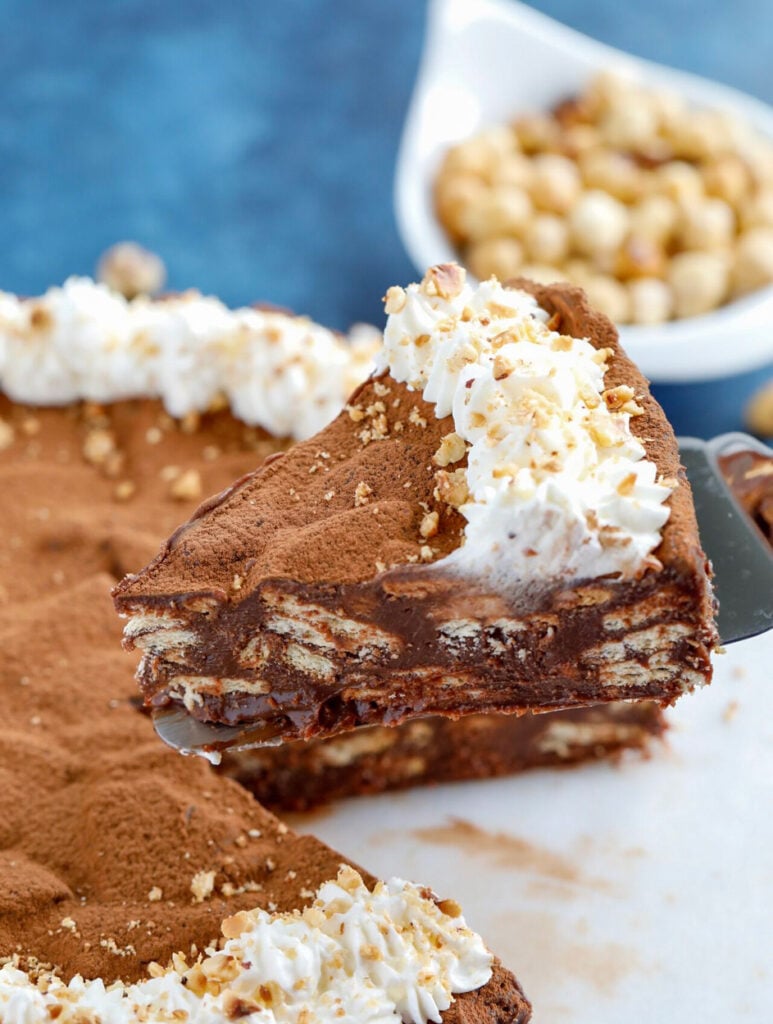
(380, 264), (672, 586)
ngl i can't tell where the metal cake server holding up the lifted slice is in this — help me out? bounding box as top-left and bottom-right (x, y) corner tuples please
(153, 433), (773, 764)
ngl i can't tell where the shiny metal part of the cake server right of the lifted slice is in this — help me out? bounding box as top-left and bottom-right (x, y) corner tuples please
(678, 433), (773, 644)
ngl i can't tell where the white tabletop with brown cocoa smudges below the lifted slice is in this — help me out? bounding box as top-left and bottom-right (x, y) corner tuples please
(293, 632), (773, 1024)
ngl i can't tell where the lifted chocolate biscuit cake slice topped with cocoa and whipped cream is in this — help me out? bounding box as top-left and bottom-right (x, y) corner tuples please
(115, 265), (717, 738)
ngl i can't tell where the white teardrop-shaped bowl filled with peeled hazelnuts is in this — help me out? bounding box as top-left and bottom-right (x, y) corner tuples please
(395, 0), (773, 436)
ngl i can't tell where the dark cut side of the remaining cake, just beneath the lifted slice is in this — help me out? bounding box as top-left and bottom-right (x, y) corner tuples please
(220, 700), (667, 813)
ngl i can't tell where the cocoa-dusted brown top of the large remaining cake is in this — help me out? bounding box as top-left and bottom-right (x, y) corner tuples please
(0, 398), (348, 980)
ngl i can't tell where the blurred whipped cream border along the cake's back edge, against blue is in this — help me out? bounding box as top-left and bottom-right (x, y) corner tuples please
(0, 278), (381, 439)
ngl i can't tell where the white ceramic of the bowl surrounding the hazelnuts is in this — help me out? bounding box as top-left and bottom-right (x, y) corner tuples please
(394, 0), (773, 382)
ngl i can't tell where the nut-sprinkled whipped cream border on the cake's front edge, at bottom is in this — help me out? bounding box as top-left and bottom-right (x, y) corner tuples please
(0, 867), (492, 1024)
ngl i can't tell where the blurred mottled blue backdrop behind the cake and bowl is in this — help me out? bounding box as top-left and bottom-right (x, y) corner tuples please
(0, 0), (773, 434)
